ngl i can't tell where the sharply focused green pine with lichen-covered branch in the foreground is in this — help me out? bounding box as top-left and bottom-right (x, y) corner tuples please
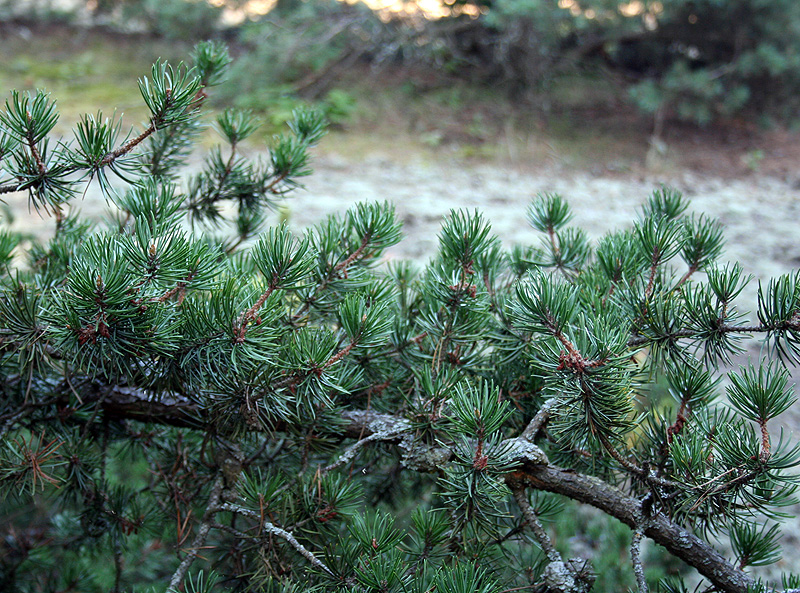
(0, 43), (800, 593)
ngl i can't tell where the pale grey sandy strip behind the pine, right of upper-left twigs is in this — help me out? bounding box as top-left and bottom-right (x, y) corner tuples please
(298, 155), (800, 286)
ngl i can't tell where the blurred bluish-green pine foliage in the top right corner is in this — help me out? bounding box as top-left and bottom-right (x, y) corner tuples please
(618, 0), (800, 125)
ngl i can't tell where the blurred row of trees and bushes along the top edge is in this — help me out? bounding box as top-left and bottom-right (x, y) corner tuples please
(6, 0), (800, 127)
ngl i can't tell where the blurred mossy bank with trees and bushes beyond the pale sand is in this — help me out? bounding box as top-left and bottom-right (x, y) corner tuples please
(0, 0), (800, 175)
